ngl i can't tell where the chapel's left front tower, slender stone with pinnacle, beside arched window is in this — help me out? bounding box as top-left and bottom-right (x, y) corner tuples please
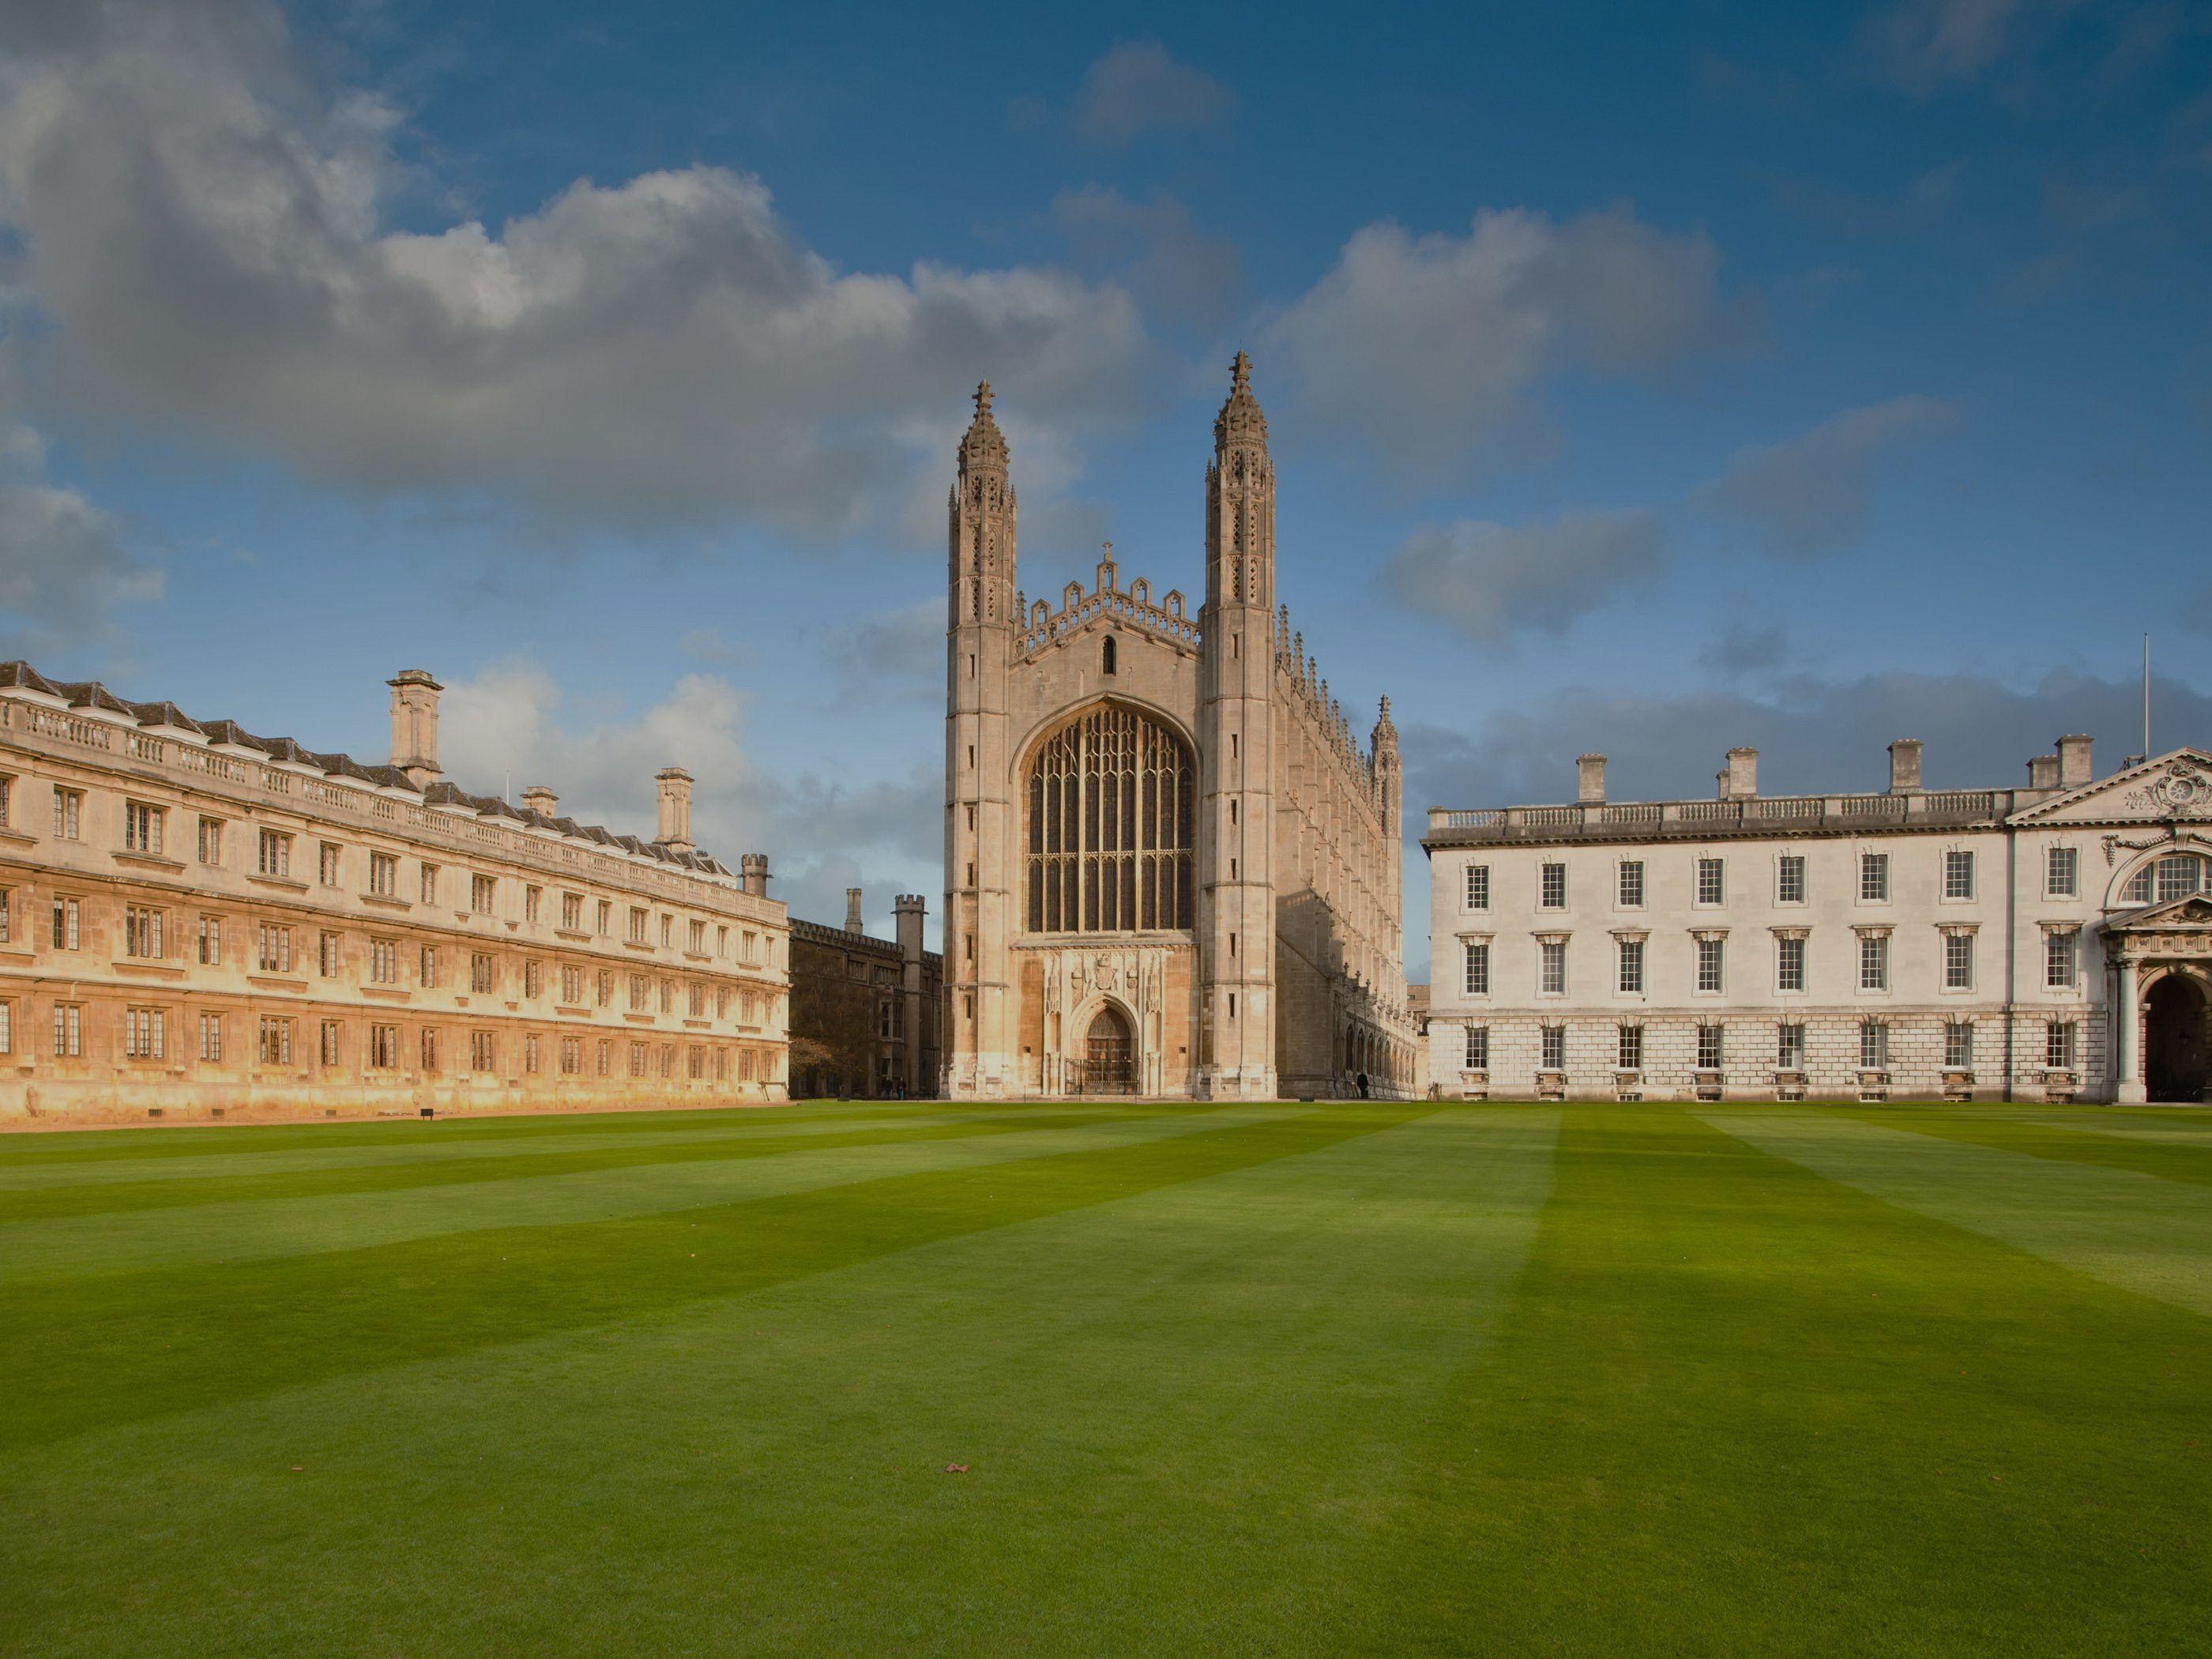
(945, 381), (1018, 1100)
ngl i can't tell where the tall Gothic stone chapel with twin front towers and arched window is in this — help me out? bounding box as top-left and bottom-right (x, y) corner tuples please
(945, 352), (1418, 1100)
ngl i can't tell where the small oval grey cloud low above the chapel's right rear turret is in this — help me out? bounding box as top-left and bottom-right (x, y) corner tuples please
(1382, 511), (1664, 644)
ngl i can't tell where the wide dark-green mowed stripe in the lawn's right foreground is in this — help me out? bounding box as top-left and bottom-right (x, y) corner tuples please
(1371, 1106), (2212, 1659)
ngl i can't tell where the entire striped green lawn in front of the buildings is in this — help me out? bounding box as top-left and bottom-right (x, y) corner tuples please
(0, 1104), (2212, 1659)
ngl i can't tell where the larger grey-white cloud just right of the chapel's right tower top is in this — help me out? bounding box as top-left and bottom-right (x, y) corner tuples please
(1270, 208), (1743, 473)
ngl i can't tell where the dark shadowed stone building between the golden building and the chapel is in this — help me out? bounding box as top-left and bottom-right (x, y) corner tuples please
(792, 887), (945, 1100)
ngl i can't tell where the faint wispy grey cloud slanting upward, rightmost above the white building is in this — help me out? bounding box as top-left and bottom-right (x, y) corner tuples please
(1708, 396), (1960, 558)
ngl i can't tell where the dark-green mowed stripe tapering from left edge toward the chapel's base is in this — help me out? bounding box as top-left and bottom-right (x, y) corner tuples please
(0, 1108), (1411, 1446)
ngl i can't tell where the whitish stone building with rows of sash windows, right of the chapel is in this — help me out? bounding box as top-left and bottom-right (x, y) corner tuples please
(1422, 736), (2212, 1101)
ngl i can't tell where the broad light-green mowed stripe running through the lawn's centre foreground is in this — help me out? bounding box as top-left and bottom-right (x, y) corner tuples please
(0, 1108), (1553, 1654)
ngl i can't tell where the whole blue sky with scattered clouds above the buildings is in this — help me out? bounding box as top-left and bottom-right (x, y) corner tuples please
(0, 0), (2212, 976)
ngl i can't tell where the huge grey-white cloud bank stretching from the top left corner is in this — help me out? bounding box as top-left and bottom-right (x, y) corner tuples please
(0, 0), (1148, 531)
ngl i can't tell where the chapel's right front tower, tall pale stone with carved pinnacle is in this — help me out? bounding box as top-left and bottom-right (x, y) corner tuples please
(1197, 352), (1277, 1100)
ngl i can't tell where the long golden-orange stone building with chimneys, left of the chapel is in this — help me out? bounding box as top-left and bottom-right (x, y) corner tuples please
(0, 664), (790, 1122)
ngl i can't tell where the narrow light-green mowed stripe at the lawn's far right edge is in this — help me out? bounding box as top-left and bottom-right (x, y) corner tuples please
(1706, 1111), (2212, 1314)
